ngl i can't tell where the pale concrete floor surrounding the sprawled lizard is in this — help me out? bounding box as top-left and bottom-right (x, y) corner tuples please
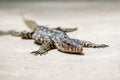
(0, 2), (120, 80)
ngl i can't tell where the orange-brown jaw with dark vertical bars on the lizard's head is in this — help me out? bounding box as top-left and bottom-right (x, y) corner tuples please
(60, 42), (83, 53)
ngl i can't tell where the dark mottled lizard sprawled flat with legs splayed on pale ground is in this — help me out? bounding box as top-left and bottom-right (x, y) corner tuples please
(11, 19), (108, 55)
